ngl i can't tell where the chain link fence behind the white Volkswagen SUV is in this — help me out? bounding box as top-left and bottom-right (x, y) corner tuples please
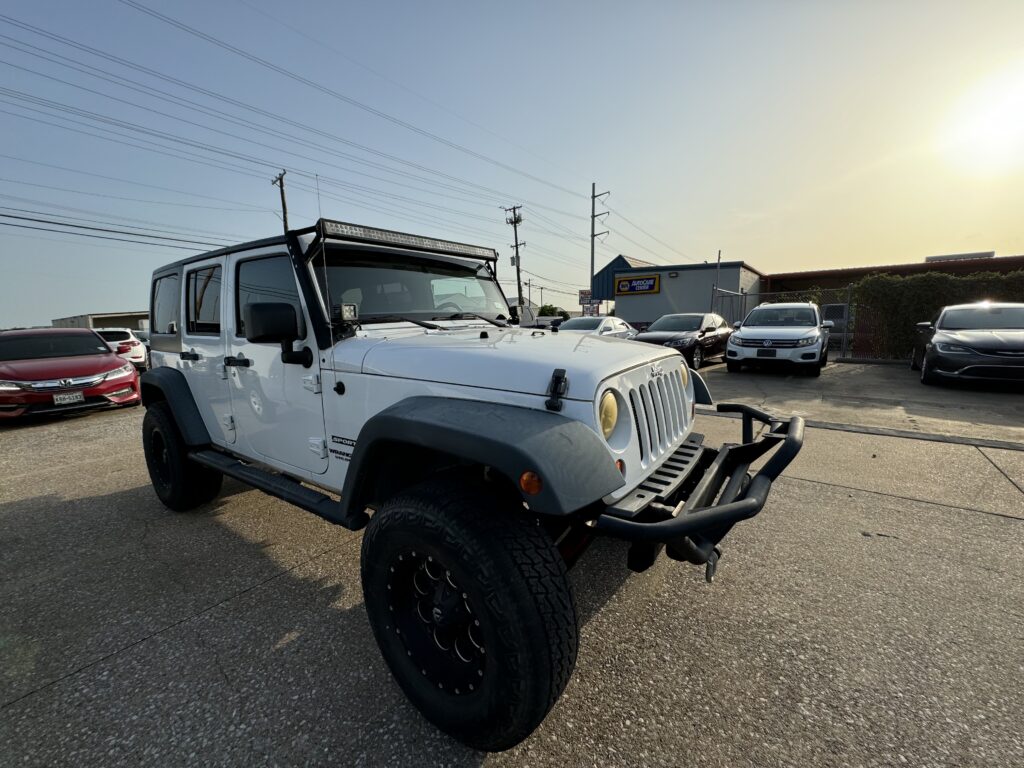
(713, 286), (873, 357)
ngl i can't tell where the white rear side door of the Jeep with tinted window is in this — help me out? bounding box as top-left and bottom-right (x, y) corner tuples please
(179, 256), (236, 445)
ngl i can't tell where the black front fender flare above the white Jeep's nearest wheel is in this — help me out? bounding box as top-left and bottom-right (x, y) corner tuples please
(341, 396), (625, 515)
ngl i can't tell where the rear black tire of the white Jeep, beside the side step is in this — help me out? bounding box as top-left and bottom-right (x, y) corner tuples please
(142, 402), (224, 512)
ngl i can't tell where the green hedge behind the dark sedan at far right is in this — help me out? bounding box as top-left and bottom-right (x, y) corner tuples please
(853, 269), (1024, 359)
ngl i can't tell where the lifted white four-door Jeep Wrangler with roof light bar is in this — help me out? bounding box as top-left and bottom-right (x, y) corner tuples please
(141, 220), (803, 751)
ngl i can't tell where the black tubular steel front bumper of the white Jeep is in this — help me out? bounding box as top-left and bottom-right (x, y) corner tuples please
(590, 403), (804, 581)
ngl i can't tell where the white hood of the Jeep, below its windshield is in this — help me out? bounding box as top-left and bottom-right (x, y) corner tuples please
(346, 327), (682, 400)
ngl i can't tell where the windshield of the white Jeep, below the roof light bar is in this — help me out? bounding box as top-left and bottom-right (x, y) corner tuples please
(313, 250), (509, 323)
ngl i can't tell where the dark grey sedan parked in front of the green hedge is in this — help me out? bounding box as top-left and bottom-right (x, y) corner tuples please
(910, 302), (1024, 384)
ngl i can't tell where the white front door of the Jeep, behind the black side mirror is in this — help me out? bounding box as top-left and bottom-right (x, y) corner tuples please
(226, 252), (328, 474)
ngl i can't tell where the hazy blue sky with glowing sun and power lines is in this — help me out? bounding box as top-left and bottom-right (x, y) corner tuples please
(0, 0), (1024, 327)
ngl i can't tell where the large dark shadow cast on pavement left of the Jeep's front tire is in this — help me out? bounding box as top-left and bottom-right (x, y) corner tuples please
(0, 482), (629, 766)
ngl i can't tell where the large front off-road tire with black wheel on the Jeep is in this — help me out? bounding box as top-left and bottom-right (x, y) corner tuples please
(361, 479), (579, 752)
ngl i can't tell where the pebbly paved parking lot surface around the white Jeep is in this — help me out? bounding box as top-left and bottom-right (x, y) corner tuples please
(0, 366), (1024, 768)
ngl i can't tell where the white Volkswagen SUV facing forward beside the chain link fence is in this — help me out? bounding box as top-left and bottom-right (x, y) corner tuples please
(725, 302), (834, 376)
